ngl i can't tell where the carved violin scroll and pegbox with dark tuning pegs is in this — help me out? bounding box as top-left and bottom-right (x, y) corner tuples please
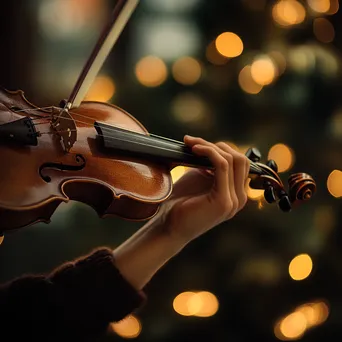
(246, 148), (316, 212)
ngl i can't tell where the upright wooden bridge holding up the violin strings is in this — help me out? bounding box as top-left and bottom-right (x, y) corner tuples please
(51, 107), (77, 152)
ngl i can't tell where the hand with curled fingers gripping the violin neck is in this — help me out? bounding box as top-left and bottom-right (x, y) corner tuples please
(158, 136), (249, 242)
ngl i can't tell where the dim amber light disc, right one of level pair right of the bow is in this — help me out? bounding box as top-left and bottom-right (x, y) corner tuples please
(172, 57), (202, 85)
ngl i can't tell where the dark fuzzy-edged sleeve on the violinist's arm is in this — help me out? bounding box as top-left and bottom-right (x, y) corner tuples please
(0, 248), (146, 341)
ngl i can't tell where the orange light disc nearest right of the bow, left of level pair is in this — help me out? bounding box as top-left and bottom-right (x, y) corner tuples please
(135, 56), (168, 87)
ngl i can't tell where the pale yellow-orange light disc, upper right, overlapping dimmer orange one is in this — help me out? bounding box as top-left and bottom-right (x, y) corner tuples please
(251, 56), (277, 86)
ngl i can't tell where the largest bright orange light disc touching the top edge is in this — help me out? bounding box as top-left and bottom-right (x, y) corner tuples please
(272, 0), (306, 27)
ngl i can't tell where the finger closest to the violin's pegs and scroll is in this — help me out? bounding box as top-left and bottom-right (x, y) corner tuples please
(216, 142), (249, 211)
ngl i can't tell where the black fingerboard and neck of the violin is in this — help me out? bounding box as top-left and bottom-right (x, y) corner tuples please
(94, 122), (259, 173)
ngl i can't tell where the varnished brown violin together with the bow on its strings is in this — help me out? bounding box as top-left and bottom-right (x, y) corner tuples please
(0, 0), (316, 235)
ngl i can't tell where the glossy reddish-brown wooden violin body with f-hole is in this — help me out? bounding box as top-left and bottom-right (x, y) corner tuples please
(0, 91), (172, 231)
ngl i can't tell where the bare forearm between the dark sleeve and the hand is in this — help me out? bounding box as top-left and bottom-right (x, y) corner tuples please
(113, 216), (187, 290)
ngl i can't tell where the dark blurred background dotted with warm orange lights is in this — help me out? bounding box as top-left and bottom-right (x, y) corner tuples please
(0, 0), (342, 342)
